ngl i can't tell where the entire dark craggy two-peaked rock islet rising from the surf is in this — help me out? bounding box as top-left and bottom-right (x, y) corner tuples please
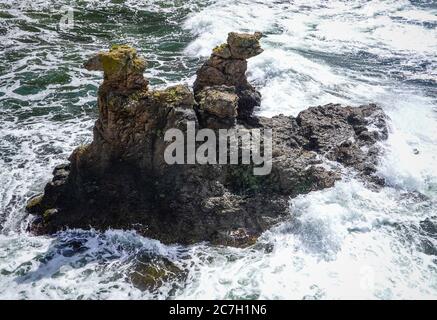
(27, 33), (387, 246)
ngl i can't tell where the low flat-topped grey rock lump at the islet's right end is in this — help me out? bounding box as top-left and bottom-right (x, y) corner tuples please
(296, 104), (388, 183)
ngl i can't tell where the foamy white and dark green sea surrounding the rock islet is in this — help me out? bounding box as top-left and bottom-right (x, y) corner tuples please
(0, 0), (437, 299)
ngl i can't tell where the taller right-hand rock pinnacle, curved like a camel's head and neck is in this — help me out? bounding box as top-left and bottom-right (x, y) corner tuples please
(193, 32), (263, 121)
